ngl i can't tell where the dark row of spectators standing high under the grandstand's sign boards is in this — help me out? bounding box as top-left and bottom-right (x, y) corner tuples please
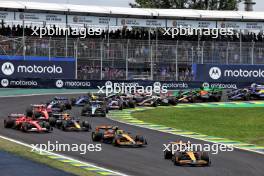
(0, 25), (264, 42)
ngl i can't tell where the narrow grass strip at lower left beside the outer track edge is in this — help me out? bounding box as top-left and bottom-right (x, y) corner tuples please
(0, 138), (97, 176)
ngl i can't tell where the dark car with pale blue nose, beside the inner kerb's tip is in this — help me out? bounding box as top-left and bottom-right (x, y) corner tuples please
(81, 100), (108, 117)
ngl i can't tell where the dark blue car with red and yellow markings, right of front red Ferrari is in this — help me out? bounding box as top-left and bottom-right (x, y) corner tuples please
(50, 113), (92, 131)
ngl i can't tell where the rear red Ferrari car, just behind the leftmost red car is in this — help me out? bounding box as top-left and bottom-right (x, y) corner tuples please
(26, 104), (52, 121)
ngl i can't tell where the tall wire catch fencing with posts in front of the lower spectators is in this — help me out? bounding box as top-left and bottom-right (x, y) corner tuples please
(0, 37), (264, 81)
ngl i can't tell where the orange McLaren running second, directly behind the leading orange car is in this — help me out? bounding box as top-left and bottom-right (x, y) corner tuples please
(92, 126), (147, 147)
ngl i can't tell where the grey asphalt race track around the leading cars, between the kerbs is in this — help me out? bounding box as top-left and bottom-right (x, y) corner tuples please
(0, 95), (264, 176)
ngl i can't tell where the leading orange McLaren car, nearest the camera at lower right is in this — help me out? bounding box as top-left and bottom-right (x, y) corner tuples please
(164, 141), (211, 166)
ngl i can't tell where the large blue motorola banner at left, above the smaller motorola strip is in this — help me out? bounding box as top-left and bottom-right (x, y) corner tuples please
(0, 56), (75, 79)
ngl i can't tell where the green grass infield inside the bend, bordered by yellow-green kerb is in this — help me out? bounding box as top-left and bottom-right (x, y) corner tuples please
(133, 107), (264, 146)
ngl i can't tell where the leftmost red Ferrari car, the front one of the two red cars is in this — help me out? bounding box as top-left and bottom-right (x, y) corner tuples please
(4, 114), (52, 132)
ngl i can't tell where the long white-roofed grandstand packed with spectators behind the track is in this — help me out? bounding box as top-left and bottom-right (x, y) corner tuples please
(0, 1), (264, 81)
